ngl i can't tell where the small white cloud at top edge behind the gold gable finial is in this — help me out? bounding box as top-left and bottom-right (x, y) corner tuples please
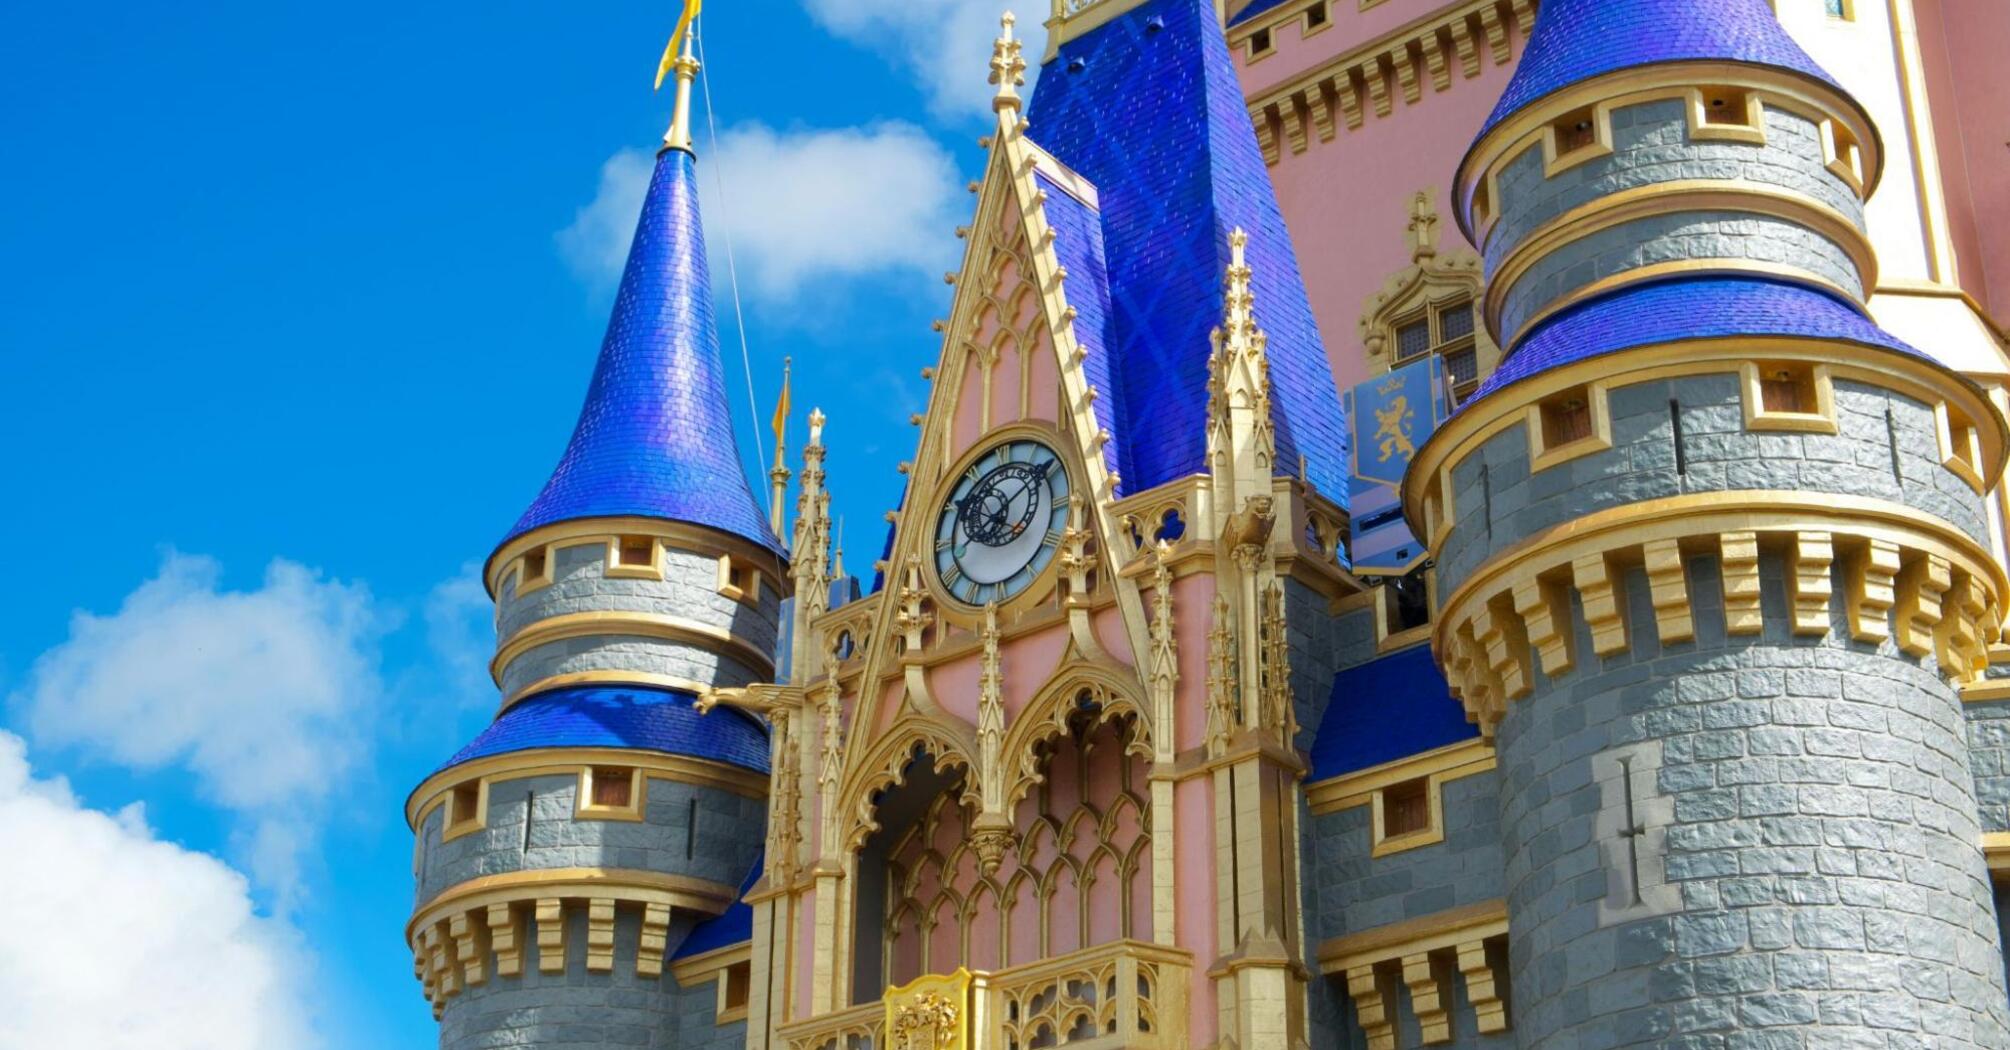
(804, 0), (1047, 117)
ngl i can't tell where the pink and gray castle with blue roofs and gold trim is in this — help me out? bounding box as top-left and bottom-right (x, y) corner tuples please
(395, 0), (2010, 1050)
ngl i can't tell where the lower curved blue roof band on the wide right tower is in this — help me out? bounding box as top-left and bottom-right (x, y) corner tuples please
(1461, 278), (1926, 410)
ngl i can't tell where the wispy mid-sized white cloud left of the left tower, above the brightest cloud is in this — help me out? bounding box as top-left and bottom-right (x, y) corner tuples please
(14, 553), (388, 901)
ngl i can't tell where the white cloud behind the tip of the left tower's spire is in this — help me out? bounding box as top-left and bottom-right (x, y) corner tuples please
(559, 123), (969, 308)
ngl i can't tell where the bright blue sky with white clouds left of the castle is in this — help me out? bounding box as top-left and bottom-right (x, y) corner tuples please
(0, 0), (1037, 1050)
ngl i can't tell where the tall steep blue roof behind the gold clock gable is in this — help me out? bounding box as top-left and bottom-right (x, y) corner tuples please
(1027, 0), (1347, 503)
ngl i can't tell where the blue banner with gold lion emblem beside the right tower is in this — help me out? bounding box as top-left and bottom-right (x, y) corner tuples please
(1347, 354), (1449, 575)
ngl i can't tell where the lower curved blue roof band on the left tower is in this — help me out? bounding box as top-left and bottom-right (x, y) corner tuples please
(440, 686), (768, 774)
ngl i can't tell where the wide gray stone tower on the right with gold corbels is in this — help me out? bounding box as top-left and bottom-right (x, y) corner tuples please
(1405, 0), (2010, 1048)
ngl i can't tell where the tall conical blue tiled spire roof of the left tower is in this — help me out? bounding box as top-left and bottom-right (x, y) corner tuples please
(505, 149), (782, 553)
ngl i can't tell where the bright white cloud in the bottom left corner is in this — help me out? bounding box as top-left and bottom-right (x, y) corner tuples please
(0, 732), (320, 1050)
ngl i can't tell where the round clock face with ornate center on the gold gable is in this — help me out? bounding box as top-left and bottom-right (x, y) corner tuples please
(935, 441), (1067, 605)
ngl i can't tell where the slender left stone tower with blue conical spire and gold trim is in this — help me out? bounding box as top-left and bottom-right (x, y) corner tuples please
(408, 36), (788, 1050)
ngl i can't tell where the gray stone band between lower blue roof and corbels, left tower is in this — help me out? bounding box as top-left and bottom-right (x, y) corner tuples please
(418, 764), (768, 907)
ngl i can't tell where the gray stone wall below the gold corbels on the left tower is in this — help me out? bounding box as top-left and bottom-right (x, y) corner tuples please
(440, 907), (746, 1050)
